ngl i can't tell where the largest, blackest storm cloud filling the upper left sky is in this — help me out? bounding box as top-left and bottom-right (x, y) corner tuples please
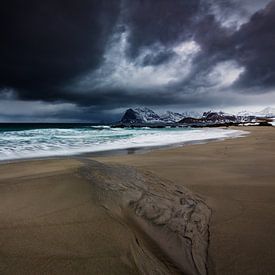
(0, 0), (119, 99)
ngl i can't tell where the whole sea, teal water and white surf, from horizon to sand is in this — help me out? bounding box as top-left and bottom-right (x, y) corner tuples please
(0, 123), (248, 161)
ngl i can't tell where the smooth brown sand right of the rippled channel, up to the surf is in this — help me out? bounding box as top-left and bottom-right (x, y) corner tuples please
(98, 127), (275, 274)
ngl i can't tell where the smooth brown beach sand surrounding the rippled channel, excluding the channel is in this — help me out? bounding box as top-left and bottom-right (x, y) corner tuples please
(0, 127), (275, 274)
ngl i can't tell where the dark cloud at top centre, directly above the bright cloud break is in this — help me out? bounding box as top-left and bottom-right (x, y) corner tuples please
(123, 0), (200, 56)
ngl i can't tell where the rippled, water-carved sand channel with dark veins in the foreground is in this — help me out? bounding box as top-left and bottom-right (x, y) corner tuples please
(79, 159), (211, 274)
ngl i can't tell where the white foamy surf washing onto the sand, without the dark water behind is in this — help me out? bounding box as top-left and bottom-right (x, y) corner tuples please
(0, 128), (246, 163)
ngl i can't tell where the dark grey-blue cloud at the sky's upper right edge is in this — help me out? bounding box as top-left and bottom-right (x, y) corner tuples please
(234, 1), (275, 87)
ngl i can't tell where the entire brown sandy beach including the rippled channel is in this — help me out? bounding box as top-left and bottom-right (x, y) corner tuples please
(0, 127), (275, 274)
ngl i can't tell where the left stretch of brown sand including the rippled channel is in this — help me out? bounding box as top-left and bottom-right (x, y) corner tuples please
(0, 158), (210, 274)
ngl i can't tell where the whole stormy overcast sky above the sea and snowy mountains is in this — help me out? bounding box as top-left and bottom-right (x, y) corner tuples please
(0, 0), (275, 122)
